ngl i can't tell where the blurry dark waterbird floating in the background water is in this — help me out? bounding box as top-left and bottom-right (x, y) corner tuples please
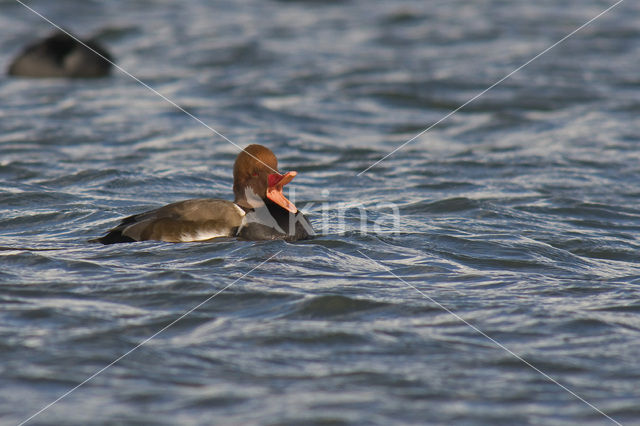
(8, 31), (113, 78)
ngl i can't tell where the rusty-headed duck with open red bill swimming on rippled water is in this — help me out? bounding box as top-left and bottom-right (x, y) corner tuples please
(91, 144), (315, 245)
